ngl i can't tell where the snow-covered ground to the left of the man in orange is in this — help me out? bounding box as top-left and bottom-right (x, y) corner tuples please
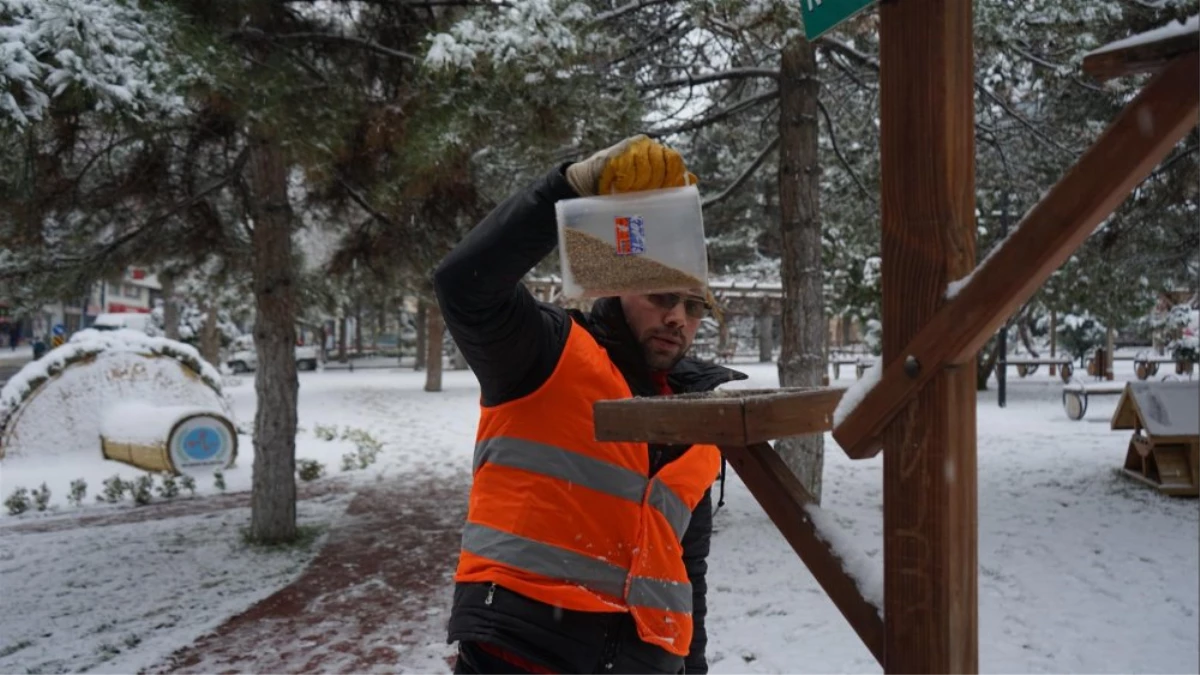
(0, 370), (479, 675)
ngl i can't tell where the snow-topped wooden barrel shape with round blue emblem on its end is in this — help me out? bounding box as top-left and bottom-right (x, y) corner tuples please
(100, 401), (238, 473)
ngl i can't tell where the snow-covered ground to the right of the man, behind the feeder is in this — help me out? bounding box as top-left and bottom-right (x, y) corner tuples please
(708, 362), (1200, 675)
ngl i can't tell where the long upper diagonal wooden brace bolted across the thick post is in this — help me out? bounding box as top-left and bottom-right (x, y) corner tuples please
(834, 52), (1200, 459)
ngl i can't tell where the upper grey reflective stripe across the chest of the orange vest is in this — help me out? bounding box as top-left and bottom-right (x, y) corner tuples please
(474, 436), (691, 540)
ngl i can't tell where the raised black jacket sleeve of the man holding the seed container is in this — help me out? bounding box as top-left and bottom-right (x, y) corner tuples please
(433, 165), (577, 406)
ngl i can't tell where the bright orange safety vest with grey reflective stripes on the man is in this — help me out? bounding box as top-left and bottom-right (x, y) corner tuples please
(455, 321), (720, 656)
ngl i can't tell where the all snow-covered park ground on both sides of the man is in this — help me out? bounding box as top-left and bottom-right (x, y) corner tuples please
(0, 362), (1200, 675)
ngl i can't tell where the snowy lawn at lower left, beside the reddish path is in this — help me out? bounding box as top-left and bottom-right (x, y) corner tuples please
(0, 494), (349, 675)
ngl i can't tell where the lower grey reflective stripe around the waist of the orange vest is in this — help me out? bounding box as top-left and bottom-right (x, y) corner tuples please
(462, 522), (691, 614)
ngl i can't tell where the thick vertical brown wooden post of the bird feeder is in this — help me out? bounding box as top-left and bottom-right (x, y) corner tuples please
(880, 0), (978, 675)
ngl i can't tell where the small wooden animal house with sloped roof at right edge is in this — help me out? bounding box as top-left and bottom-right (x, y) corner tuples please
(1112, 381), (1200, 497)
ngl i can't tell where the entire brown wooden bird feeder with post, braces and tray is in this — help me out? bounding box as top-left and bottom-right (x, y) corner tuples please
(595, 10), (1200, 675)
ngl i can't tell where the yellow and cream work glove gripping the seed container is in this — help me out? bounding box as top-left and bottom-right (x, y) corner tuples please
(566, 135), (696, 197)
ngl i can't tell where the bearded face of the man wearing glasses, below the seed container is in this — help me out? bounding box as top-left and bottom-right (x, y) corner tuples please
(620, 289), (708, 370)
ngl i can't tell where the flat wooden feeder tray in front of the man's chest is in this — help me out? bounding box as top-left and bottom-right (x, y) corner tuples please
(593, 387), (844, 446)
